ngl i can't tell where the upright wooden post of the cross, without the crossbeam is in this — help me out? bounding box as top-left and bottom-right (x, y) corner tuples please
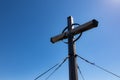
(67, 16), (78, 80)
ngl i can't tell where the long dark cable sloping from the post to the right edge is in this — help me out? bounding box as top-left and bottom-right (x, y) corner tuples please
(77, 55), (120, 78)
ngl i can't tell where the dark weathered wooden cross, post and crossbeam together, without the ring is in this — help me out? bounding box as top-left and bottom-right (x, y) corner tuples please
(51, 16), (98, 80)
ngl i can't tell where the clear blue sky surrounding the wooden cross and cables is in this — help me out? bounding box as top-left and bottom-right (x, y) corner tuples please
(0, 0), (120, 80)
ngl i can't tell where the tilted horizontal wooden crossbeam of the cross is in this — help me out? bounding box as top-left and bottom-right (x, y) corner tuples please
(51, 19), (98, 43)
